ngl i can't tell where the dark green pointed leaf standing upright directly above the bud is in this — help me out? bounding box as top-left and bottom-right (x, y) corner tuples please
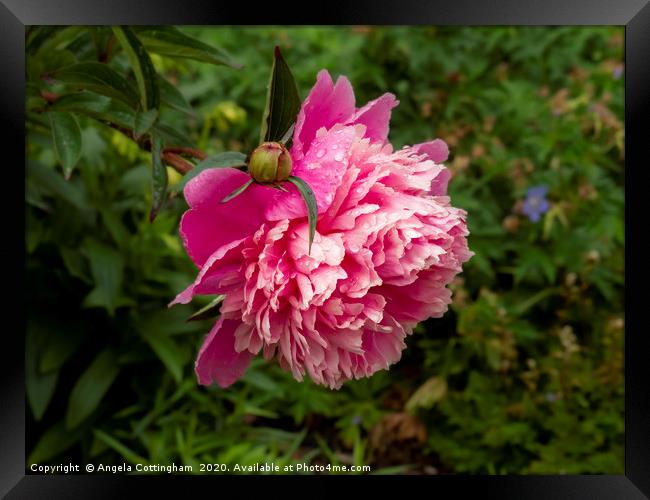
(260, 46), (300, 143)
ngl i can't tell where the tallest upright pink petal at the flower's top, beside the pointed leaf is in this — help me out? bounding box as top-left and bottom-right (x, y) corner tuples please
(291, 70), (355, 160)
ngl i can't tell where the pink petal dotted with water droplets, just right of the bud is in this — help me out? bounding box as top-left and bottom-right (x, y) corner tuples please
(266, 127), (358, 220)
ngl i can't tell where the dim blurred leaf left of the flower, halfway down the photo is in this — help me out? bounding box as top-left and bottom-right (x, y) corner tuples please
(83, 239), (127, 316)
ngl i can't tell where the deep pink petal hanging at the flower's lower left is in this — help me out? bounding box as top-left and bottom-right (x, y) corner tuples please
(194, 316), (252, 388)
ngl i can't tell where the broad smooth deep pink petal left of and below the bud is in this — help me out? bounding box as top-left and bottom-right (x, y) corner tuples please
(180, 168), (274, 267)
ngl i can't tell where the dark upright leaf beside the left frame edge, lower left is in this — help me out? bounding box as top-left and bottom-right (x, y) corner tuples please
(25, 321), (59, 421)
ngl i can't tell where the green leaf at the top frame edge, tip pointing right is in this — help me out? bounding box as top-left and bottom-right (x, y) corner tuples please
(135, 26), (243, 69)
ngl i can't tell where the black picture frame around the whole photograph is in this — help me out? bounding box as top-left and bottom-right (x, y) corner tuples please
(0, 0), (650, 499)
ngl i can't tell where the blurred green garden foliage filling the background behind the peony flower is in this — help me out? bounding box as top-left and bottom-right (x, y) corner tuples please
(26, 27), (624, 474)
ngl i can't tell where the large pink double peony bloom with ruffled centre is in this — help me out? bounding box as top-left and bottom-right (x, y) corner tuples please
(172, 70), (473, 388)
